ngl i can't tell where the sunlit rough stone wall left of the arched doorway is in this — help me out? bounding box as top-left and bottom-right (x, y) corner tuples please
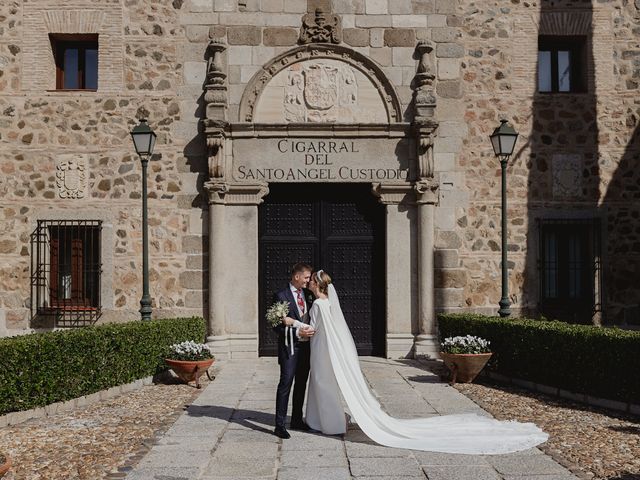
(0, 0), (207, 334)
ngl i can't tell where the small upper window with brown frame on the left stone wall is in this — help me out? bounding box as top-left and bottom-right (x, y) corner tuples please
(50, 35), (98, 90)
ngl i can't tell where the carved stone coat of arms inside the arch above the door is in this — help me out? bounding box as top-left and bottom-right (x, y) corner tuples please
(284, 62), (358, 122)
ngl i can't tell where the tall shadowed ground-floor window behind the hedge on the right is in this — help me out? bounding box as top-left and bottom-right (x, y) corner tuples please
(539, 219), (601, 323)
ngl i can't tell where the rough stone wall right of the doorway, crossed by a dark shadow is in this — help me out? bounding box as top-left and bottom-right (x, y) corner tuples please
(436, 1), (640, 323)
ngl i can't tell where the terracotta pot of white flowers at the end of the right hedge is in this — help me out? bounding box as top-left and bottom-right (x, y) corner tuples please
(440, 335), (493, 385)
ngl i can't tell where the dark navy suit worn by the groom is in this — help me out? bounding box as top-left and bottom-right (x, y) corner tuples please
(273, 285), (313, 428)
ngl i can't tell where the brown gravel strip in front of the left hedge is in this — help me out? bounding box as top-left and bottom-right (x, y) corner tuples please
(0, 375), (209, 480)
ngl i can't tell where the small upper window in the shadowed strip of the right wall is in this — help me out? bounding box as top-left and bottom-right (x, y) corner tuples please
(538, 35), (587, 93)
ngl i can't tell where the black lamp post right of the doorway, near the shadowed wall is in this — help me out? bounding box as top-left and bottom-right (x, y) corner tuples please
(489, 120), (518, 317)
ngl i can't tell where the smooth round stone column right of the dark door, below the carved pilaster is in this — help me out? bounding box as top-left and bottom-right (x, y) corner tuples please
(415, 179), (440, 358)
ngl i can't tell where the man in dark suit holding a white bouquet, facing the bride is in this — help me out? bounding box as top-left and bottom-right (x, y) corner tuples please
(273, 263), (314, 438)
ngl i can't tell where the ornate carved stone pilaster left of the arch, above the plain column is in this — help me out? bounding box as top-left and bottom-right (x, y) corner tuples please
(204, 33), (228, 179)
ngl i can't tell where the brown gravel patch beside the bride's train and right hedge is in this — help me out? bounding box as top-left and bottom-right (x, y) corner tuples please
(455, 380), (640, 480)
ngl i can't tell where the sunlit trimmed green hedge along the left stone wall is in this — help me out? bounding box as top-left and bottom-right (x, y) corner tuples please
(0, 318), (206, 415)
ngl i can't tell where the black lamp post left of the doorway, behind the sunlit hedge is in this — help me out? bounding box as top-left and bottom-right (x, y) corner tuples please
(131, 118), (156, 320)
